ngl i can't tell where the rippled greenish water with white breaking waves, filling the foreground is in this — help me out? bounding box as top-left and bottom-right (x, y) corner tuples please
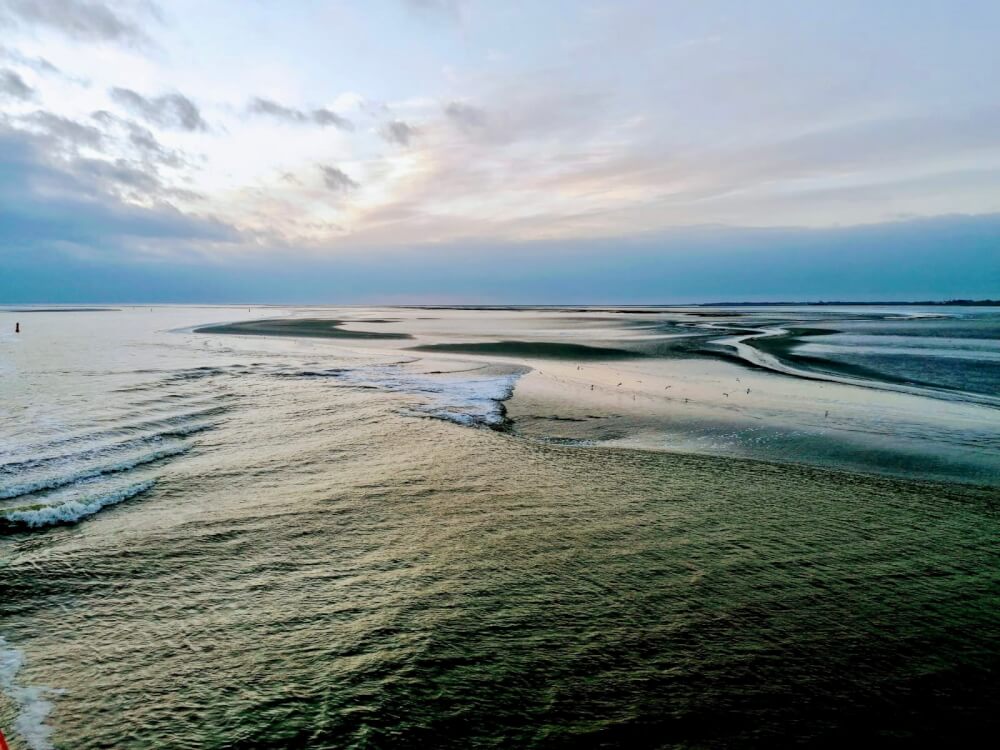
(0, 308), (1000, 750)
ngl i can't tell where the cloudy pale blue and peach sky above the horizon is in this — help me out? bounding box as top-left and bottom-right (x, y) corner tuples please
(0, 0), (1000, 304)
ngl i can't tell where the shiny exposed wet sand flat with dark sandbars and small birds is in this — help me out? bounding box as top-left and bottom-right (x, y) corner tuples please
(197, 307), (1000, 485)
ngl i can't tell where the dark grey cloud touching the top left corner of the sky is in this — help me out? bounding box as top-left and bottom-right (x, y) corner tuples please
(0, 0), (153, 43)
